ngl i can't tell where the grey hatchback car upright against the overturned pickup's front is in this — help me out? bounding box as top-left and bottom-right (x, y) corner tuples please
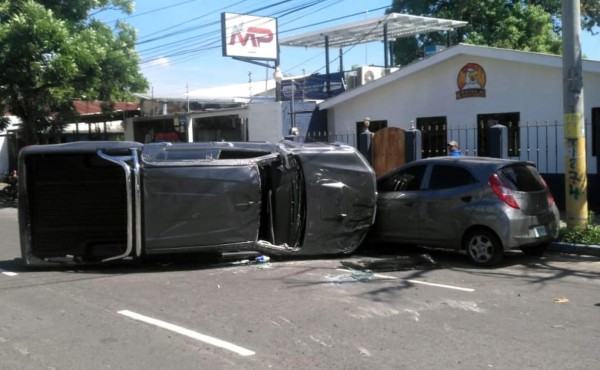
(370, 157), (559, 266)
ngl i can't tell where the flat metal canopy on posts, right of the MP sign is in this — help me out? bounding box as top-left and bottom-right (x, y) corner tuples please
(279, 13), (467, 97)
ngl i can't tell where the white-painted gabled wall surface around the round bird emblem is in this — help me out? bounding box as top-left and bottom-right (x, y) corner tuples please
(328, 54), (600, 172)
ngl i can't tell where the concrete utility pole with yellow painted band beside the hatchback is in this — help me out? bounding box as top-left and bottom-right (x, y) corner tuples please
(562, 0), (588, 228)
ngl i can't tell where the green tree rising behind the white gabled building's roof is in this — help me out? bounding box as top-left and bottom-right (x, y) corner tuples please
(388, 0), (600, 64)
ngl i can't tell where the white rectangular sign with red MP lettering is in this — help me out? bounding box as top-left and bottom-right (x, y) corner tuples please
(221, 13), (278, 60)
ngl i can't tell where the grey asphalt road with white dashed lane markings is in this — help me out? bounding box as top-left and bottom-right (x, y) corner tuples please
(0, 202), (600, 370)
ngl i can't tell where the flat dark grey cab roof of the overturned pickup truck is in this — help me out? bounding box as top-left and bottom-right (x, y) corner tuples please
(142, 164), (261, 252)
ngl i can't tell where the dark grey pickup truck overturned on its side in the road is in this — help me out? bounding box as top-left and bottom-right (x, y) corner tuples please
(19, 141), (377, 265)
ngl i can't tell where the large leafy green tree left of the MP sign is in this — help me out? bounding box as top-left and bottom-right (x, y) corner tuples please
(0, 0), (148, 145)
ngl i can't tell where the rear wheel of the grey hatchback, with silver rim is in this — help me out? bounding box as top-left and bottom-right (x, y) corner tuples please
(464, 229), (504, 267)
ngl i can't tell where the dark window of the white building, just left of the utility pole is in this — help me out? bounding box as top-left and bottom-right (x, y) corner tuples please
(477, 112), (521, 157)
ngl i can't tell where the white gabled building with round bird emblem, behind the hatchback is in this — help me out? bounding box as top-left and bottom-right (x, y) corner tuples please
(319, 44), (600, 173)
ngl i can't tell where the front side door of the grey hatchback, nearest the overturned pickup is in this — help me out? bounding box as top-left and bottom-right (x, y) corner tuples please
(373, 164), (427, 243)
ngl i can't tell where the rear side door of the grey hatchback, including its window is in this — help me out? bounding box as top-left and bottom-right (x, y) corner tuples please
(419, 164), (482, 248)
